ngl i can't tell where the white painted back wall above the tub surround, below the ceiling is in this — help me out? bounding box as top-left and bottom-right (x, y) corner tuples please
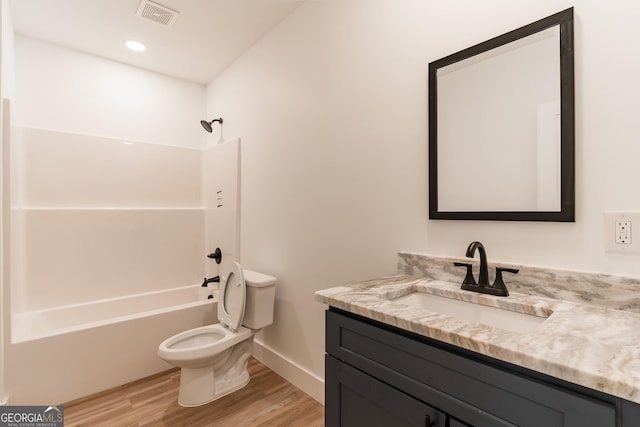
(13, 35), (206, 148)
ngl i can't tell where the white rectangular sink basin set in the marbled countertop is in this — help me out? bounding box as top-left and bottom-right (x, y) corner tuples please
(391, 292), (547, 333)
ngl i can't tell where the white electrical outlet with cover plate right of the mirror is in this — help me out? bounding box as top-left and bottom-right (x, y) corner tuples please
(604, 211), (640, 253)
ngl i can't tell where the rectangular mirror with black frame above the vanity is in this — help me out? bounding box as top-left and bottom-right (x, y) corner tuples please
(429, 9), (575, 221)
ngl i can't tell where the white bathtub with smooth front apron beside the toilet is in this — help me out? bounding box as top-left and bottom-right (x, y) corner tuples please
(7, 285), (217, 405)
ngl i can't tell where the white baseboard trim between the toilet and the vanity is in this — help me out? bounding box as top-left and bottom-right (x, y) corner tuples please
(253, 339), (324, 405)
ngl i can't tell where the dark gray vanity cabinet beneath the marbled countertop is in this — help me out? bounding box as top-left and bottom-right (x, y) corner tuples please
(325, 307), (640, 427)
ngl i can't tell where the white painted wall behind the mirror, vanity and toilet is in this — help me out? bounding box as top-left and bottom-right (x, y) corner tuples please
(207, 0), (640, 398)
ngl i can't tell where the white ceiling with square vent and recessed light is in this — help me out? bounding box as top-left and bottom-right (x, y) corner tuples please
(10, 0), (304, 84)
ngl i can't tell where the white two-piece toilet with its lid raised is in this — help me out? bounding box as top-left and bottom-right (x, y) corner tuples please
(158, 262), (276, 407)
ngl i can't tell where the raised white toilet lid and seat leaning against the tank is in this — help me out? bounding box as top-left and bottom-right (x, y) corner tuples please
(218, 262), (247, 331)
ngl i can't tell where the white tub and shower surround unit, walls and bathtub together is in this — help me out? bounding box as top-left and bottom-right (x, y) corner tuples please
(6, 127), (239, 404)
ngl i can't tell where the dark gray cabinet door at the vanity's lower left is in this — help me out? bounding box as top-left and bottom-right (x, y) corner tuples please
(325, 355), (446, 427)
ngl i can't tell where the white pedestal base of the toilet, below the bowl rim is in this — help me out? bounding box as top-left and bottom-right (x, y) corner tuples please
(178, 336), (253, 407)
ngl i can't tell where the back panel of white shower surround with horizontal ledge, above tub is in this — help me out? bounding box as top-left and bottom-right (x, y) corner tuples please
(12, 128), (204, 312)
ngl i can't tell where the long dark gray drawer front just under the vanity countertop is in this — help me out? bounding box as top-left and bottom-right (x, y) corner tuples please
(326, 311), (615, 427)
